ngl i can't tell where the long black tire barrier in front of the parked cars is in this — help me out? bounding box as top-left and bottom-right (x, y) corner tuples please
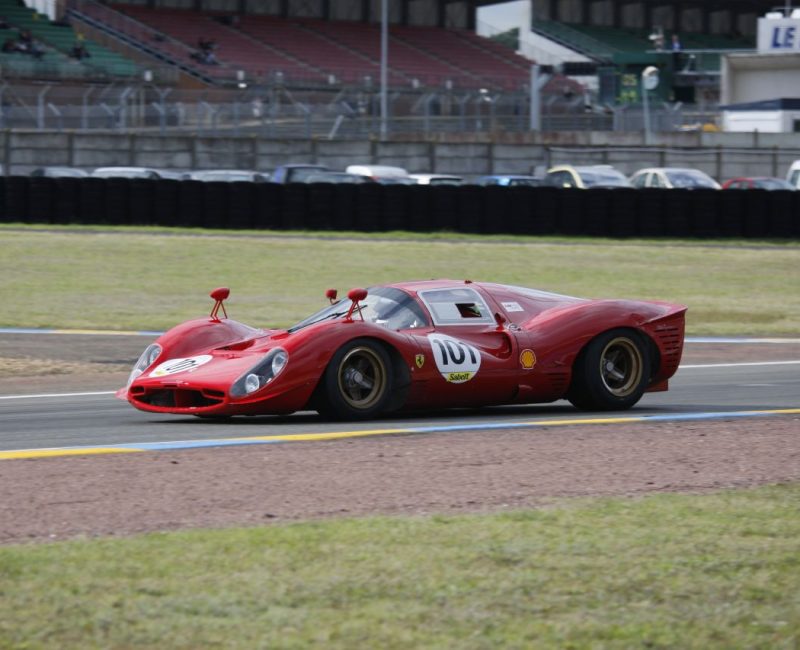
(0, 176), (800, 239)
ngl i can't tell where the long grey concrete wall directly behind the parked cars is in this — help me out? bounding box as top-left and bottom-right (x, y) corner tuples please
(9, 131), (800, 180)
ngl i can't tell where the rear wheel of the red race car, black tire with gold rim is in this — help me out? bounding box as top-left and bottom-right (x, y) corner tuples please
(567, 329), (650, 411)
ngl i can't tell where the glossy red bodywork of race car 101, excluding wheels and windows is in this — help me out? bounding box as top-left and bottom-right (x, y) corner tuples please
(117, 280), (686, 416)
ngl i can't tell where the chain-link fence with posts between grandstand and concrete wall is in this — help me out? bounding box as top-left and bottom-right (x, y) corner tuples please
(0, 82), (708, 139)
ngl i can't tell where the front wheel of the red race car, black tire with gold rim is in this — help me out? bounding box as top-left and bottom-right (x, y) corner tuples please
(317, 338), (394, 420)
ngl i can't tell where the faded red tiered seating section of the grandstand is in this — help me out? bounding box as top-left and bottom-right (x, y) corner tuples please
(64, 0), (530, 89)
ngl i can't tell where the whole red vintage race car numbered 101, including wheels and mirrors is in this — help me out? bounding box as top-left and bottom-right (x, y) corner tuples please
(117, 280), (686, 419)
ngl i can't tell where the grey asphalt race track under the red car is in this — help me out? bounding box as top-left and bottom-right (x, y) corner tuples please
(0, 354), (800, 451)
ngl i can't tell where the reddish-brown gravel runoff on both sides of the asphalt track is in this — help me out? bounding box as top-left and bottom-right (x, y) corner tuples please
(0, 335), (800, 544)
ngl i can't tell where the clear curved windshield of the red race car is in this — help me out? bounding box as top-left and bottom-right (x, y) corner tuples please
(289, 287), (428, 332)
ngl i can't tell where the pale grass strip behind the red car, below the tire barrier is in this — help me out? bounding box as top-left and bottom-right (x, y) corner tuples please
(0, 227), (800, 335)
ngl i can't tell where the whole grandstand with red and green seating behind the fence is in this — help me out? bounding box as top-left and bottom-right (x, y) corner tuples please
(0, 0), (788, 128)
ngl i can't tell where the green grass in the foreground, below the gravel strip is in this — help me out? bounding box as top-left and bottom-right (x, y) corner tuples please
(0, 485), (800, 649)
